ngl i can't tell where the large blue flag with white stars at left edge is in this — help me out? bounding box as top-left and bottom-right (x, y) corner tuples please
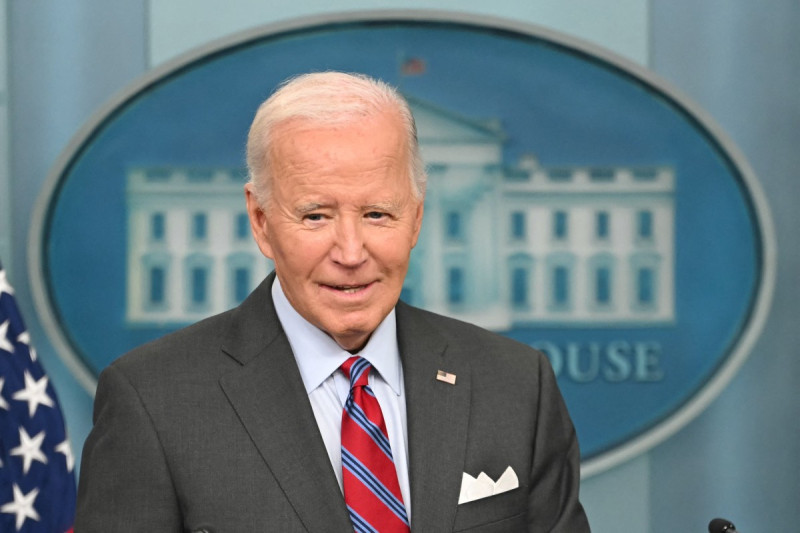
(0, 265), (75, 533)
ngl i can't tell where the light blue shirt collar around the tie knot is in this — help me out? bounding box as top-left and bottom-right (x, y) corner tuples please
(272, 276), (402, 396)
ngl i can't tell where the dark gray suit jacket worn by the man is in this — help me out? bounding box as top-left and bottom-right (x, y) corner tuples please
(75, 274), (589, 533)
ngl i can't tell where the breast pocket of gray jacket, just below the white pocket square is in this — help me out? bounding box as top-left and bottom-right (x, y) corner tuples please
(453, 486), (527, 533)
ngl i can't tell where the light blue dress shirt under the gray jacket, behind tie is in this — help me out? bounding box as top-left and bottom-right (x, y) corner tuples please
(272, 277), (411, 519)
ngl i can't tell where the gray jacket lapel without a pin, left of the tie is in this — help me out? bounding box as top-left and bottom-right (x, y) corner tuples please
(220, 275), (352, 532)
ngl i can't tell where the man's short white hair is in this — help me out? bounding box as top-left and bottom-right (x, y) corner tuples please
(247, 72), (427, 206)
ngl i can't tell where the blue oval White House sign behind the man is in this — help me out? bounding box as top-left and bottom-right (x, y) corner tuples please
(34, 14), (772, 470)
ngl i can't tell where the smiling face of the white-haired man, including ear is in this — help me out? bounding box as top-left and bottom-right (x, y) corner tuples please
(246, 111), (423, 351)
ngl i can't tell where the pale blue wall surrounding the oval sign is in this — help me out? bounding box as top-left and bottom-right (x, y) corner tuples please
(0, 0), (800, 533)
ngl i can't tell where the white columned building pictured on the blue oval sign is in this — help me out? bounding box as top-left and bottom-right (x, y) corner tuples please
(126, 98), (675, 331)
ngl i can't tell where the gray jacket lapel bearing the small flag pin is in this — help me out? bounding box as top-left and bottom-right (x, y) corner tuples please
(397, 303), (471, 531)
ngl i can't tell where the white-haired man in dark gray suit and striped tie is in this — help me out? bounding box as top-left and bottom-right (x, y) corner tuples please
(75, 72), (589, 533)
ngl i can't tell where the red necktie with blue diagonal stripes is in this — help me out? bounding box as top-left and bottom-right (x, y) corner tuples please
(342, 357), (409, 533)
